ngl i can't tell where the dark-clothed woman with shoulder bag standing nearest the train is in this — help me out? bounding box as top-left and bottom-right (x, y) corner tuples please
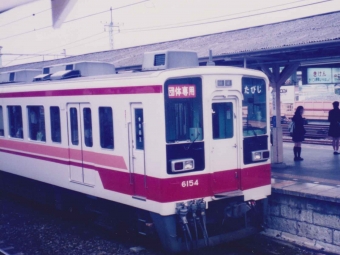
(292, 106), (306, 161)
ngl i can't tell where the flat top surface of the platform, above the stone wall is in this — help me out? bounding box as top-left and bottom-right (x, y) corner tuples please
(272, 143), (340, 185)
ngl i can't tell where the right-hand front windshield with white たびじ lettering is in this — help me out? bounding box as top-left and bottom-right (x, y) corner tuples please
(242, 77), (267, 136)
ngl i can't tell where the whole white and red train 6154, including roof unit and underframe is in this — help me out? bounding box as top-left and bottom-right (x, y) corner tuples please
(0, 50), (271, 252)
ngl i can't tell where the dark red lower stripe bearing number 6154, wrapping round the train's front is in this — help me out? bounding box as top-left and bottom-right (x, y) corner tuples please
(0, 146), (271, 203)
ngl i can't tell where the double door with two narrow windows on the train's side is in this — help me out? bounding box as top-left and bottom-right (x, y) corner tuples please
(67, 103), (94, 185)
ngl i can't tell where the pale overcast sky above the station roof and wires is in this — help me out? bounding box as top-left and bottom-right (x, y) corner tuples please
(0, 0), (340, 66)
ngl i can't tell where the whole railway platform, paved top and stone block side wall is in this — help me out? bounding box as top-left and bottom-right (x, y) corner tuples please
(262, 143), (340, 254)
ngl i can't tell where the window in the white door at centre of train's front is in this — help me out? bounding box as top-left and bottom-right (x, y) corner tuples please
(212, 103), (234, 139)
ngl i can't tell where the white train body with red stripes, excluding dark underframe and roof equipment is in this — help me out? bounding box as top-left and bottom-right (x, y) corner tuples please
(0, 51), (271, 251)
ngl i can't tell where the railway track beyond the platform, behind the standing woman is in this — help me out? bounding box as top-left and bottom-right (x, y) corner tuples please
(282, 123), (332, 145)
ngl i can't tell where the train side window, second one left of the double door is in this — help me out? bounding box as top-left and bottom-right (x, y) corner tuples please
(27, 106), (46, 142)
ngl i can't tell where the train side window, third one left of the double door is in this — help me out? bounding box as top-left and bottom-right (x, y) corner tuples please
(7, 105), (24, 139)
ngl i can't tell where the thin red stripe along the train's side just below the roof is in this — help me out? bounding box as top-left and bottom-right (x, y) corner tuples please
(0, 85), (162, 98)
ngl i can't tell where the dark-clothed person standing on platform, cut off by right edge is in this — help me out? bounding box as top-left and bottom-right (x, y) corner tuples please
(328, 101), (340, 155)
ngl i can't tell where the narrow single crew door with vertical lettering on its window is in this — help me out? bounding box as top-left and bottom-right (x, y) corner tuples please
(130, 103), (146, 199)
